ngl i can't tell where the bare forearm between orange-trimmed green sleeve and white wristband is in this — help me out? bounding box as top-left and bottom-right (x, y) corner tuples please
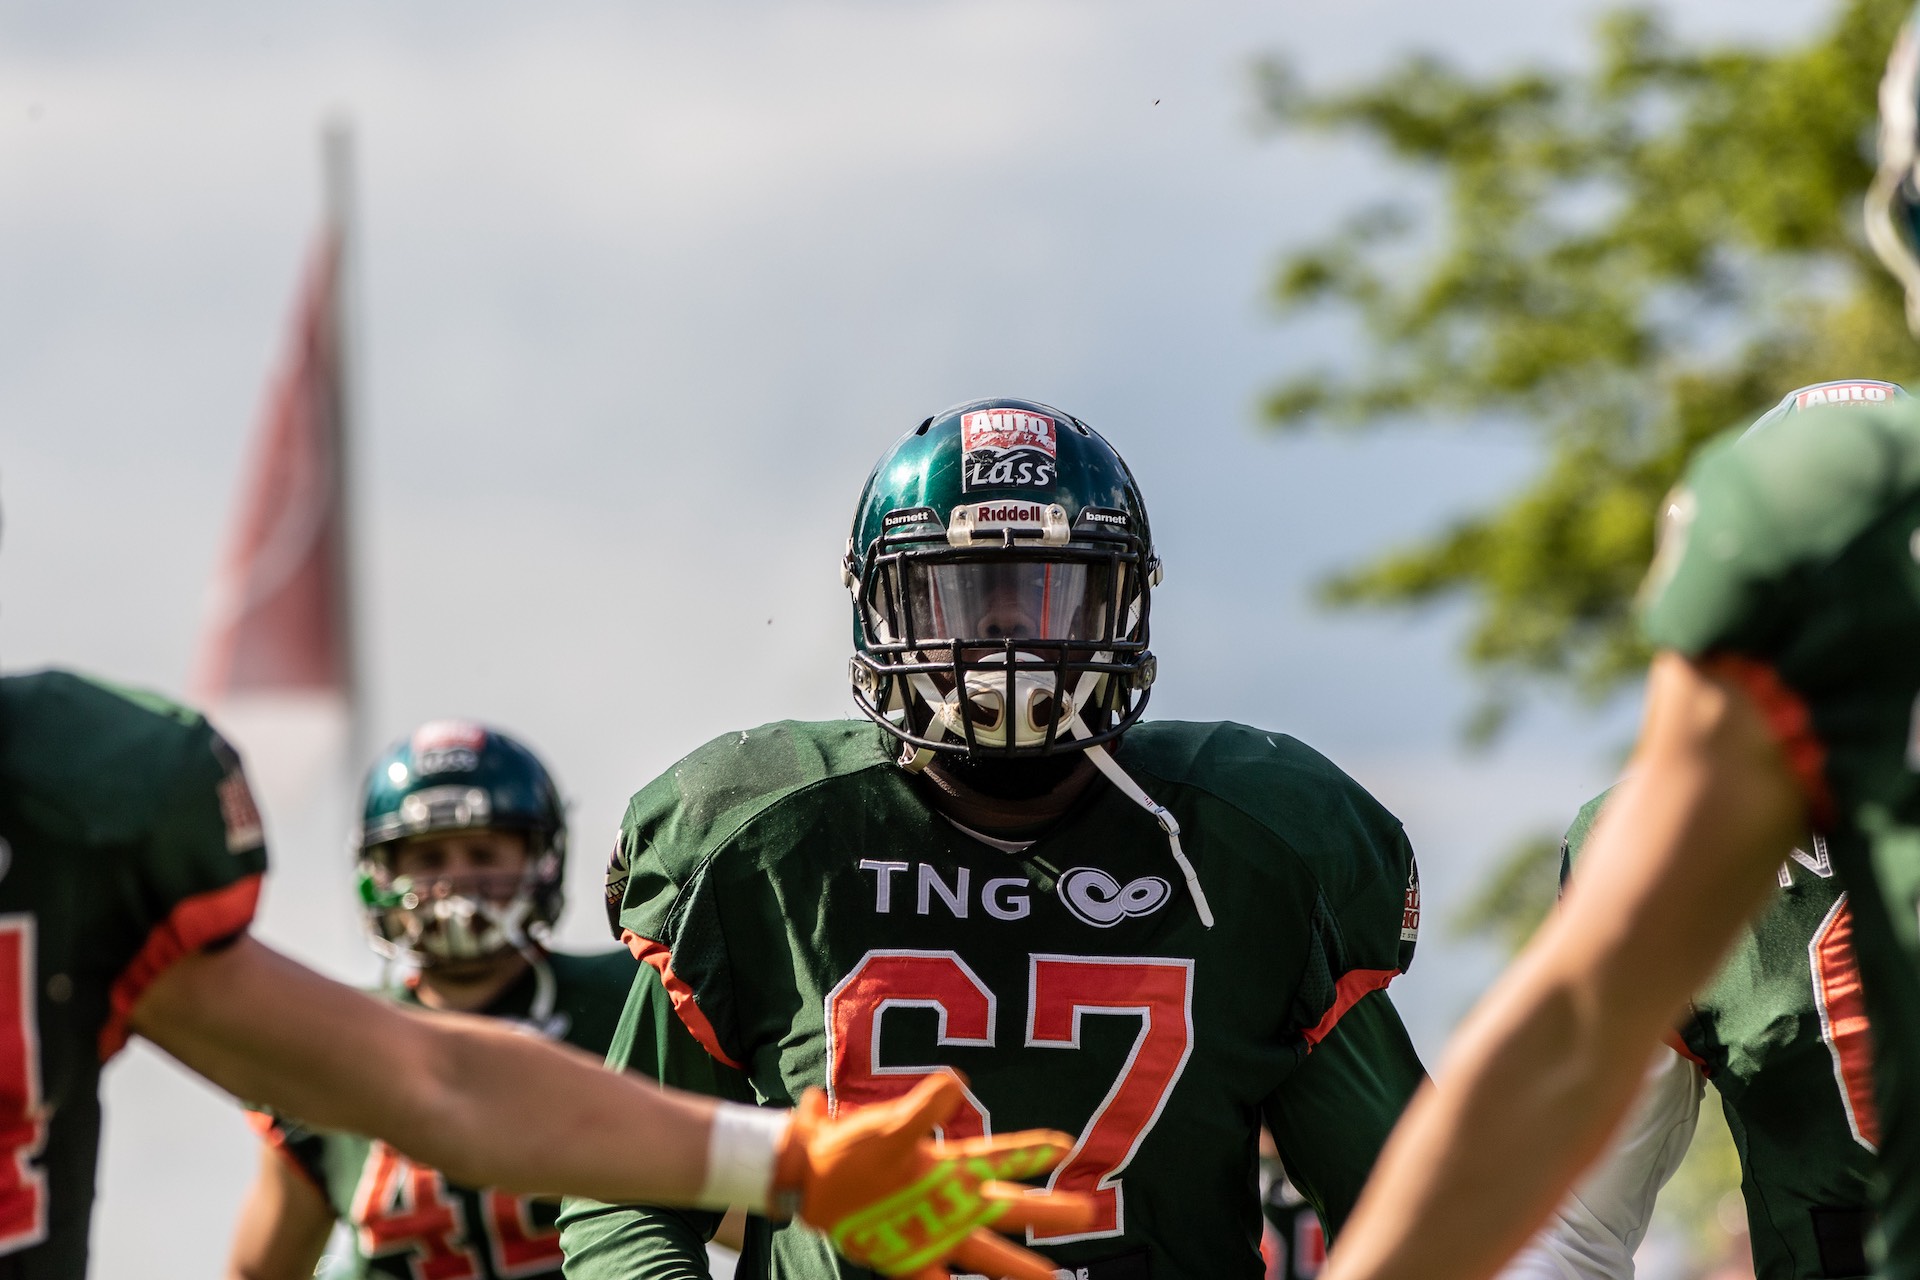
(134, 938), (714, 1203)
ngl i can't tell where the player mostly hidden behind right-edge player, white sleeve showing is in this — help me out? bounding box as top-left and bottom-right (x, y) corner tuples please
(1503, 378), (1908, 1280)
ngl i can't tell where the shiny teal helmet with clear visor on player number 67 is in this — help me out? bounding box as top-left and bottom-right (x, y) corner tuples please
(841, 399), (1162, 768)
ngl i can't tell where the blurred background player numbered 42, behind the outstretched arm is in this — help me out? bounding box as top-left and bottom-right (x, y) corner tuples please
(230, 720), (648, 1280)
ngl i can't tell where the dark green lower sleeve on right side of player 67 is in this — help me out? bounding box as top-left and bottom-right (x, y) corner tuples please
(1263, 990), (1427, 1238)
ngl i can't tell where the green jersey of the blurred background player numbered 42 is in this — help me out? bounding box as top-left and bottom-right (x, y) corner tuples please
(255, 952), (636, 1280)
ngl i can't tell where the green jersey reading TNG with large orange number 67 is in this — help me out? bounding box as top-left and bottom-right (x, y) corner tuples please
(561, 722), (1423, 1280)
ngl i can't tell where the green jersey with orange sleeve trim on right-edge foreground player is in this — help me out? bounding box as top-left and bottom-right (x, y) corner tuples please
(1644, 403), (1920, 1276)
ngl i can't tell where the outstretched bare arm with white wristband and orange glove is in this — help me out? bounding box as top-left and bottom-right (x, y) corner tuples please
(132, 936), (1092, 1280)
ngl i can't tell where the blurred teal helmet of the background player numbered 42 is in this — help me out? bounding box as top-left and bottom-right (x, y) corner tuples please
(353, 720), (566, 965)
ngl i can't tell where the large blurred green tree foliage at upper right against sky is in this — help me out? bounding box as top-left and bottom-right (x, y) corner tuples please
(1261, 0), (1920, 733)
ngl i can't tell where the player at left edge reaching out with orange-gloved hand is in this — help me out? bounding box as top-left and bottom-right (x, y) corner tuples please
(0, 672), (1091, 1280)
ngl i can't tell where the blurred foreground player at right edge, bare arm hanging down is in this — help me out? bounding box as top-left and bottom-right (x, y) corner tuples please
(1329, 52), (1920, 1280)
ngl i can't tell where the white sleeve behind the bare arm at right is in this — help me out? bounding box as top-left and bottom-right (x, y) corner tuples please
(1500, 1050), (1705, 1280)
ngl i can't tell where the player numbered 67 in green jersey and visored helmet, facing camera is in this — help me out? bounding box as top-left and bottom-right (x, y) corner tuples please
(561, 399), (1423, 1280)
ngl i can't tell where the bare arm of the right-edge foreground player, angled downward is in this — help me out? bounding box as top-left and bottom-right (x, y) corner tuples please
(1327, 652), (1807, 1280)
